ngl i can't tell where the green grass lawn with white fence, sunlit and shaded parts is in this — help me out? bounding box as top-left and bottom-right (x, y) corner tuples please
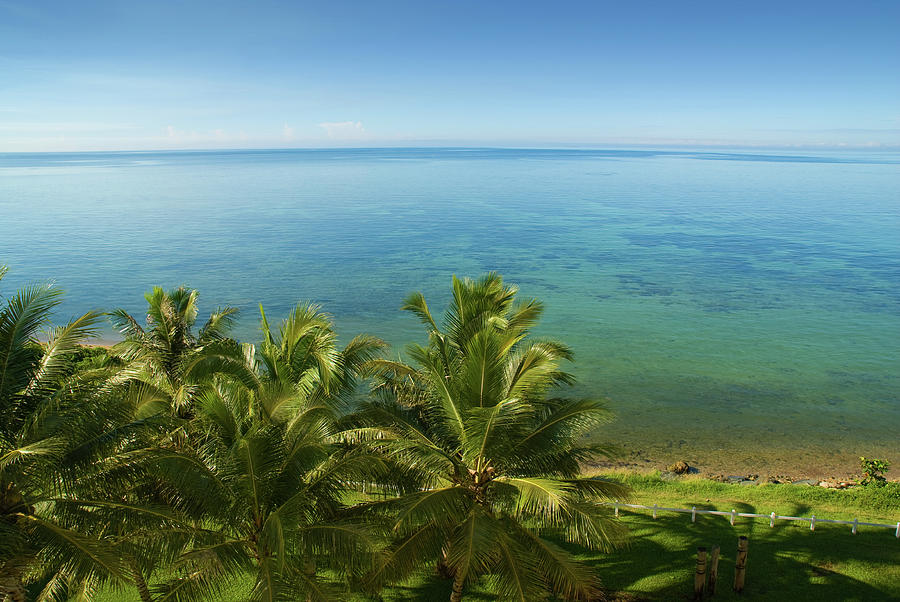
(98, 474), (900, 602)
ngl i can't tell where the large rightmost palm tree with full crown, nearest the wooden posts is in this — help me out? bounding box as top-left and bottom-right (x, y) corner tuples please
(363, 274), (625, 601)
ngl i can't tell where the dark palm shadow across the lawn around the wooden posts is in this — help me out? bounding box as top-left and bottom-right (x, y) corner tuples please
(573, 504), (900, 602)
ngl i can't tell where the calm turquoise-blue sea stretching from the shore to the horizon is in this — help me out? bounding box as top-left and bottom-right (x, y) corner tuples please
(0, 149), (900, 468)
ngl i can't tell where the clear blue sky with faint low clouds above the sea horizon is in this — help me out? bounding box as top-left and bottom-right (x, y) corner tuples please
(0, 0), (900, 151)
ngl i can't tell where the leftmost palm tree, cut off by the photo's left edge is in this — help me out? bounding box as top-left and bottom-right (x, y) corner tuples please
(0, 266), (127, 601)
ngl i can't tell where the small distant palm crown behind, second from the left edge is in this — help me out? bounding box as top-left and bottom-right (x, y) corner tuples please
(110, 287), (255, 418)
